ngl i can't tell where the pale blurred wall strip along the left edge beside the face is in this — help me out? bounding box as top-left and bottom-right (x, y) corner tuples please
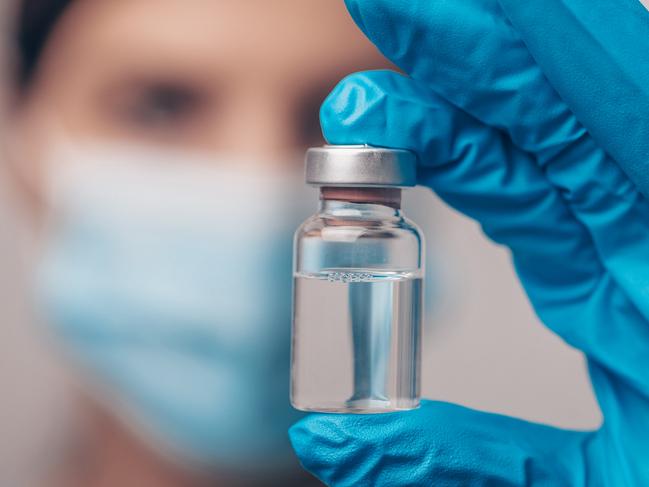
(0, 0), (75, 487)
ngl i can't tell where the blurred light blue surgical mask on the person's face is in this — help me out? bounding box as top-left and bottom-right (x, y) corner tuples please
(38, 145), (314, 476)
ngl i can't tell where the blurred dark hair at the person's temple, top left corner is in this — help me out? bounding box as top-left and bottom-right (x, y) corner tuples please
(14, 0), (72, 88)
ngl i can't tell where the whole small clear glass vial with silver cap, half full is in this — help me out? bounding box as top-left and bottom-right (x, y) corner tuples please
(291, 146), (423, 413)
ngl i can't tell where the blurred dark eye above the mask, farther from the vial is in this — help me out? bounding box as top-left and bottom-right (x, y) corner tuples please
(106, 82), (208, 129)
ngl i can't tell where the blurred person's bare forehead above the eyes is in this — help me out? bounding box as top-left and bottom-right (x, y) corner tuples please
(36, 0), (384, 88)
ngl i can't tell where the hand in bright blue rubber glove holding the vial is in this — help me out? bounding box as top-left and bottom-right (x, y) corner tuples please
(290, 0), (649, 487)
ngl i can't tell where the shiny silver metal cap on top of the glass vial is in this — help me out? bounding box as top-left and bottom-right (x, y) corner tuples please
(305, 145), (417, 188)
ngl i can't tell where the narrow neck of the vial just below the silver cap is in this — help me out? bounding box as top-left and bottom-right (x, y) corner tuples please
(320, 187), (401, 218)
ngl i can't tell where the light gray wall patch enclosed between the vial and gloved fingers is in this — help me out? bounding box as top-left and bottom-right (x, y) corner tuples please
(404, 188), (600, 428)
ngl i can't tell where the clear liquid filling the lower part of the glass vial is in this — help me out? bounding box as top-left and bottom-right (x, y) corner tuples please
(291, 269), (422, 413)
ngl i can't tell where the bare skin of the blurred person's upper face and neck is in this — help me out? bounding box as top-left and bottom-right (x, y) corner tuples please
(3, 0), (387, 487)
